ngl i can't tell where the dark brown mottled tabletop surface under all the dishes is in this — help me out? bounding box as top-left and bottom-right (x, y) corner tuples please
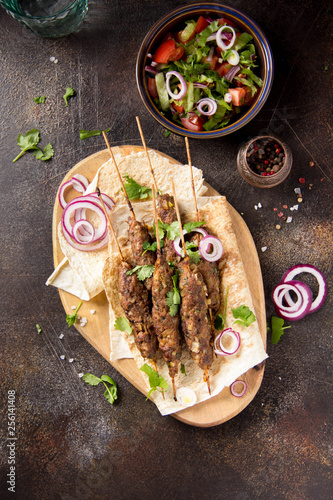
(0, 0), (333, 500)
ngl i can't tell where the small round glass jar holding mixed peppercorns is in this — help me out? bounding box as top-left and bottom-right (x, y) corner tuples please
(237, 135), (293, 188)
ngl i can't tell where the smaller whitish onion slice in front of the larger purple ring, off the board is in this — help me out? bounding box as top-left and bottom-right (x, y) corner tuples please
(273, 281), (312, 321)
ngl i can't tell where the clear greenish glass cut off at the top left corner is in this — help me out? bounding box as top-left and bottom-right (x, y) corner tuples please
(0, 0), (88, 38)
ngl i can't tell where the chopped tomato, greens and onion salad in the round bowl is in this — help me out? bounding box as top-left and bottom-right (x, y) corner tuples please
(145, 16), (263, 132)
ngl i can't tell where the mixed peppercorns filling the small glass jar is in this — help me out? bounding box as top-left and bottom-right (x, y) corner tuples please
(246, 139), (285, 176)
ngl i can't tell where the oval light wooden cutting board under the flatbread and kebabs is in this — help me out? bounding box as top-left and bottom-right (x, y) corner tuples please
(52, 145), (266, 427)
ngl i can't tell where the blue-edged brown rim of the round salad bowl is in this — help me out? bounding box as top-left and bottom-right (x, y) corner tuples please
(136, 2), (274, 139)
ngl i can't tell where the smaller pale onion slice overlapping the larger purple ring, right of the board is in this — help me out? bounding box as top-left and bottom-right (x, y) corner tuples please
(272, 280), (312, 321)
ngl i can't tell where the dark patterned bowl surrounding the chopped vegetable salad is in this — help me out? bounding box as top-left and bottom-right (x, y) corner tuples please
(136, 2), (273, 139)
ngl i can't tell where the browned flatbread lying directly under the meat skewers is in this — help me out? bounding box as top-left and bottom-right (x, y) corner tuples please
(102, 196), (267, 415)
